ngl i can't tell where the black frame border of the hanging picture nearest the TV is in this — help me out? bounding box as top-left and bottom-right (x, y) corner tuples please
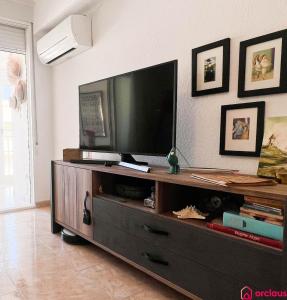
(191, 38), (230, 97)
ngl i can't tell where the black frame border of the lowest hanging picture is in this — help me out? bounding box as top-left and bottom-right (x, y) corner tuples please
(222, 101), (265, 157)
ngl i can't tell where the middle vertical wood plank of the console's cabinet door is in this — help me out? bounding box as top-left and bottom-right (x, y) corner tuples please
(63, 166), (77, 228)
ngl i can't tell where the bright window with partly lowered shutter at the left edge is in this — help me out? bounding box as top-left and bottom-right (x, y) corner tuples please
(0, 23), (31, 211)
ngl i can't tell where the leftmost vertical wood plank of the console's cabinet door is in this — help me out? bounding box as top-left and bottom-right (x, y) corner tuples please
(53, 164), (65, 223)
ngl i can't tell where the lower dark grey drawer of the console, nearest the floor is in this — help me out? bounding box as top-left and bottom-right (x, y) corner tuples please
(94, 216), (239, 300)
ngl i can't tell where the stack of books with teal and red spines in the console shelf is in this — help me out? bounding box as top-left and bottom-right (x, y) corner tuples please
(207, 199), (283, 249)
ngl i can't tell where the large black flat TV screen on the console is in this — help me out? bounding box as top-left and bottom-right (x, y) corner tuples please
(79, 61), (177, 155)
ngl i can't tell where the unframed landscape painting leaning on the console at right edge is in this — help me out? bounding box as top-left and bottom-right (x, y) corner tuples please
(257, 116), (287, 178)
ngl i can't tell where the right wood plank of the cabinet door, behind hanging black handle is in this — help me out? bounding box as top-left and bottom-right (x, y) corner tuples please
(77, 169), (93, 238)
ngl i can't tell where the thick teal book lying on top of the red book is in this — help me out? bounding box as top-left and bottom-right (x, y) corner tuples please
(223, 212), (283, 241)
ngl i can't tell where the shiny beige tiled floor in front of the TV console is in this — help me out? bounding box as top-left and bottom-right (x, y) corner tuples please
(0, 208), (189, 300)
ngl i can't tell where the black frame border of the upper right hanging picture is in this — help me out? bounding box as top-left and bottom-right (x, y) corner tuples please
(237, 29), (287, 98)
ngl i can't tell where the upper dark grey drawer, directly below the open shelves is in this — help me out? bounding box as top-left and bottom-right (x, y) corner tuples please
(94, 198), (282, 288)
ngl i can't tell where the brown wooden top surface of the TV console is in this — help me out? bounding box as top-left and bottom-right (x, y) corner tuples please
(55, 161), (287, 203)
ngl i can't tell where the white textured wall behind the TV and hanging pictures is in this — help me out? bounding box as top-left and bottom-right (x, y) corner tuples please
(50, 0), (287, 173)
